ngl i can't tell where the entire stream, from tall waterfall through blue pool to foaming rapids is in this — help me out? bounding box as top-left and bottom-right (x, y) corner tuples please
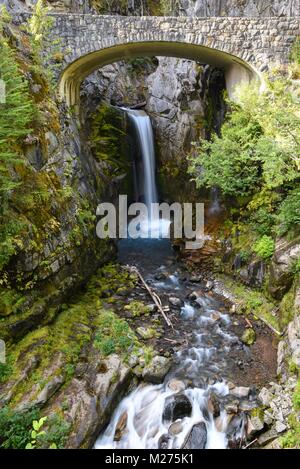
(95, 111), (254, 449)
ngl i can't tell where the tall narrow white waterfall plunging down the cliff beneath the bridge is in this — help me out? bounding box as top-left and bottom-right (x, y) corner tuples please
(126, 109), (158, 210)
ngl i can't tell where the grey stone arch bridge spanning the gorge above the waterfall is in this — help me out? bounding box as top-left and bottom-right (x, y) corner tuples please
(34, 13), (300, 105)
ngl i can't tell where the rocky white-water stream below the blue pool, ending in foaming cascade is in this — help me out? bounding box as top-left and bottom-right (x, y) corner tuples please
(95, 265), (251, 449)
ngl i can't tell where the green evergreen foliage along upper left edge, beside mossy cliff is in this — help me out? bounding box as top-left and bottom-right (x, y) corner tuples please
(0, 24), (37, 270)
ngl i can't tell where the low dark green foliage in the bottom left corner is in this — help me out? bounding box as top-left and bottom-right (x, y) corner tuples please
(0, 406), (39, 449)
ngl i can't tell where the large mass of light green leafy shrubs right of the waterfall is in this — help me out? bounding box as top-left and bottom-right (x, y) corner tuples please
(189, 41), (300, 259)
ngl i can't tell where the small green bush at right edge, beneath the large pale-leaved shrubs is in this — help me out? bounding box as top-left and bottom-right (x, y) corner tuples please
(276, 187), (300, 235)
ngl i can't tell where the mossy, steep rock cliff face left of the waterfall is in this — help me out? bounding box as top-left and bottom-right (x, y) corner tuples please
(0, 20), (123, 342)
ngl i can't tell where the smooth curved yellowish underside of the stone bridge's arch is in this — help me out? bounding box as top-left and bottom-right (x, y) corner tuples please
(59, 41), (259, 106)
